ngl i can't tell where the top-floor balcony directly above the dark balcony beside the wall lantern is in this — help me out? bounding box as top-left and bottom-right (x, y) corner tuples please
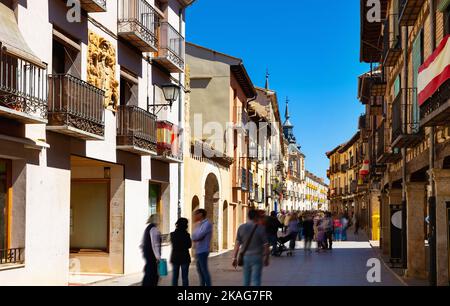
(118, 0), (161, 52)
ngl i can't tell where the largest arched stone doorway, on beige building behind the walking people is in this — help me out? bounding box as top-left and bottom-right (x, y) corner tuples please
(205, 173), (220, 252)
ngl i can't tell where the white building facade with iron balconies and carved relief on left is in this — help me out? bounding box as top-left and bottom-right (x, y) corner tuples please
(0, 0), (194, 285)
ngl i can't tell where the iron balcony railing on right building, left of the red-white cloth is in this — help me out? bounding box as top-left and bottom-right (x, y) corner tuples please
(392, 88), (420, 141)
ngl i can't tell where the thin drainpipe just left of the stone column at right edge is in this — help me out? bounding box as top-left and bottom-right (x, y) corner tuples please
(428, 0), (437, 286)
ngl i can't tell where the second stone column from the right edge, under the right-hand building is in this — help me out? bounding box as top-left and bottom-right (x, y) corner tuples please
(406, 182), (427, 279)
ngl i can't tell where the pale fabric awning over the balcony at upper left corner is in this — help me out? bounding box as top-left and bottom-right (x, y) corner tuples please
(0, 3), (46, 68)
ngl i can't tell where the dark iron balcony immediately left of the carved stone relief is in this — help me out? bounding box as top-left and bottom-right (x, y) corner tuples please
(47, 74), (105, 140)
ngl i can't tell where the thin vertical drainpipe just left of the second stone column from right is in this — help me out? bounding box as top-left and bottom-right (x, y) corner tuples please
(400, 26), (408, 269)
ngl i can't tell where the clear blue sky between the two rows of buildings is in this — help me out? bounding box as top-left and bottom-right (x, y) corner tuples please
(186, 0), (369, 177)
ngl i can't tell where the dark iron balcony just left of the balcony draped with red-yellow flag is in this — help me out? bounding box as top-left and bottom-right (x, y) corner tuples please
(117, 105), (156, 156)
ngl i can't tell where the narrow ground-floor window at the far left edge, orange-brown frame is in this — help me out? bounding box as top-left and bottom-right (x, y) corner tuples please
(0, 159), (11, 252)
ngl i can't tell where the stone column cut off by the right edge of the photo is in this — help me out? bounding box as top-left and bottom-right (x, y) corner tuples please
(433, 169), (450, 286)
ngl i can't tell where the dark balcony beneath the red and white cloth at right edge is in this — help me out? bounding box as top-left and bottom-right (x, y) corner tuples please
(420, 80), (450, 126)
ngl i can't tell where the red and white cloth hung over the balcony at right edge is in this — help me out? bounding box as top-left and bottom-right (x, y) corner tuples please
(417, 35), (450, 105)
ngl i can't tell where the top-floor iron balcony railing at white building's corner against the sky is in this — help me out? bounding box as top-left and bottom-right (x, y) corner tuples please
(158, 22), (185, 69)
